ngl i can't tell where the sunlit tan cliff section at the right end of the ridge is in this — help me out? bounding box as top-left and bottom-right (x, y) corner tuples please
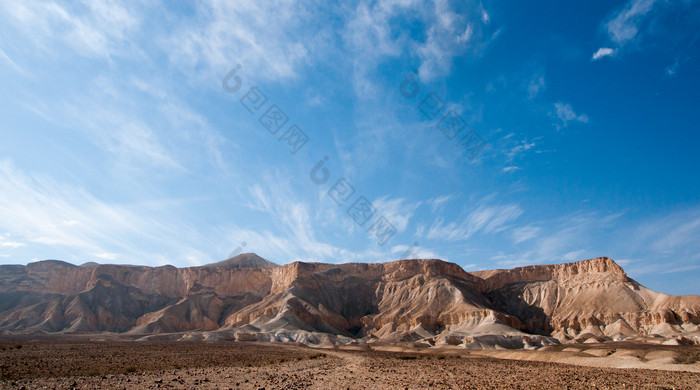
(477, 257), (700, 341)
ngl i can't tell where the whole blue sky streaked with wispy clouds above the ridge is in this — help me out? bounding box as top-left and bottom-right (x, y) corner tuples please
(0, 0), (700, 294)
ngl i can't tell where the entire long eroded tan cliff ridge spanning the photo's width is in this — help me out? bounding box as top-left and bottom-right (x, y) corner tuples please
(0, 254), (700, 348)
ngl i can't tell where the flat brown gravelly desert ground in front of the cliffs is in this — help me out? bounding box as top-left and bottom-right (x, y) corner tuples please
(0, 340), (700, 389)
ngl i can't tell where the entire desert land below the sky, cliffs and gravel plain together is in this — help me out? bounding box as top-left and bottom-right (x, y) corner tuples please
(0, 254), (700, 390)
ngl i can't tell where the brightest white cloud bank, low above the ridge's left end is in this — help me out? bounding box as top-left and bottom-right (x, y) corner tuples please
(0, 162), (219, 263)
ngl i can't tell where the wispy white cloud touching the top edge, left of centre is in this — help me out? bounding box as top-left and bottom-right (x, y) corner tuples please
(163, 0), (314, 80)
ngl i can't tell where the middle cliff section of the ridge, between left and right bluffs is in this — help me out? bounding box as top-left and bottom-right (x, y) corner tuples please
(225, 260), (487, 337)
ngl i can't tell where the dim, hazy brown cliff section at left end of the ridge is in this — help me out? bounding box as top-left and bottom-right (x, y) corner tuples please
(0, 261), (272, 332)
